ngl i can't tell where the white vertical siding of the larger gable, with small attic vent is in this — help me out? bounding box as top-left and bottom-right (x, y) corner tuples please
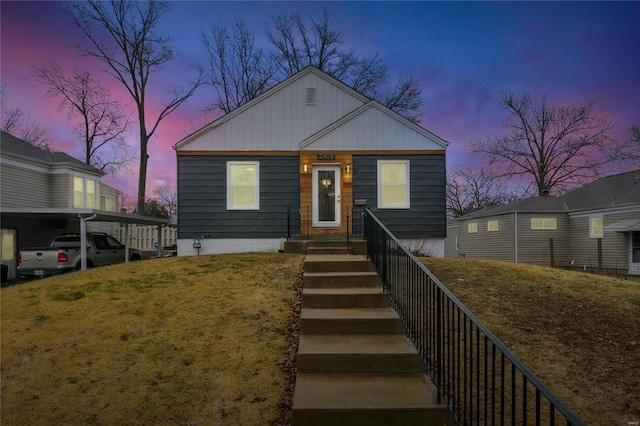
(180, 73), (364, 151)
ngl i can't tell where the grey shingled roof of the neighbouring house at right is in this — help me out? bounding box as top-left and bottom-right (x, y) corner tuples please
(458, 170), (640, 220)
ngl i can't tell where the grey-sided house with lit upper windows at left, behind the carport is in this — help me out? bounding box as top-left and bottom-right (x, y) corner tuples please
(0, 132), (166, 279)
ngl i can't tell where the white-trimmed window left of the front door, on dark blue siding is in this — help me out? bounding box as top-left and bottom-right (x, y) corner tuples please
(227, 161), (260, 210)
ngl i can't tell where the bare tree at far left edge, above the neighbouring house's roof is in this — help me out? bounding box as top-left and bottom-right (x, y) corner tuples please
(0, 83), (51, 151)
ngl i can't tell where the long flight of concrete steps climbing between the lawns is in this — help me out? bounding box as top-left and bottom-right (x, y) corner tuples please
(293, 254), (453, 426)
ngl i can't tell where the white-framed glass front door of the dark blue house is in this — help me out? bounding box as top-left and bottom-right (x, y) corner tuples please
(312, 165), (340, 228)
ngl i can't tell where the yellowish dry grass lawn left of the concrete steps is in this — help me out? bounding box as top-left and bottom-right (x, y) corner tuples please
(0, 254), (302, 425)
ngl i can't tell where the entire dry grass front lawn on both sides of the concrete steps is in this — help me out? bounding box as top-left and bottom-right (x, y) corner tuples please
(0, 254), (640, 425)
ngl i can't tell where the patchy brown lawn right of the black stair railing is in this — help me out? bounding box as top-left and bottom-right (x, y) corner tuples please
(421, 258), (640, 426)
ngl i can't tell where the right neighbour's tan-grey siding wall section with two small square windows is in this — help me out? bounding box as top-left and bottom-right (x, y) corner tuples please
(458, 213), (515, 262)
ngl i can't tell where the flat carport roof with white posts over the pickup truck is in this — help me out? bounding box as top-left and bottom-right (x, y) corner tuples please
(1, 207), (169, 270)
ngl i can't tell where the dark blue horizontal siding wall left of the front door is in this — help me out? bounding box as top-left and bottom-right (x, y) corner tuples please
(178, 155), (300, 239)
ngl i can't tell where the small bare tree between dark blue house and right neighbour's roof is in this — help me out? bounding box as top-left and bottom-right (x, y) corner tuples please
(446, 166), (521, 217)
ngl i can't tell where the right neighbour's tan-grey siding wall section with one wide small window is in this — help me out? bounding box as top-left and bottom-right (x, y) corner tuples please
(517, 213), (570, 266)
